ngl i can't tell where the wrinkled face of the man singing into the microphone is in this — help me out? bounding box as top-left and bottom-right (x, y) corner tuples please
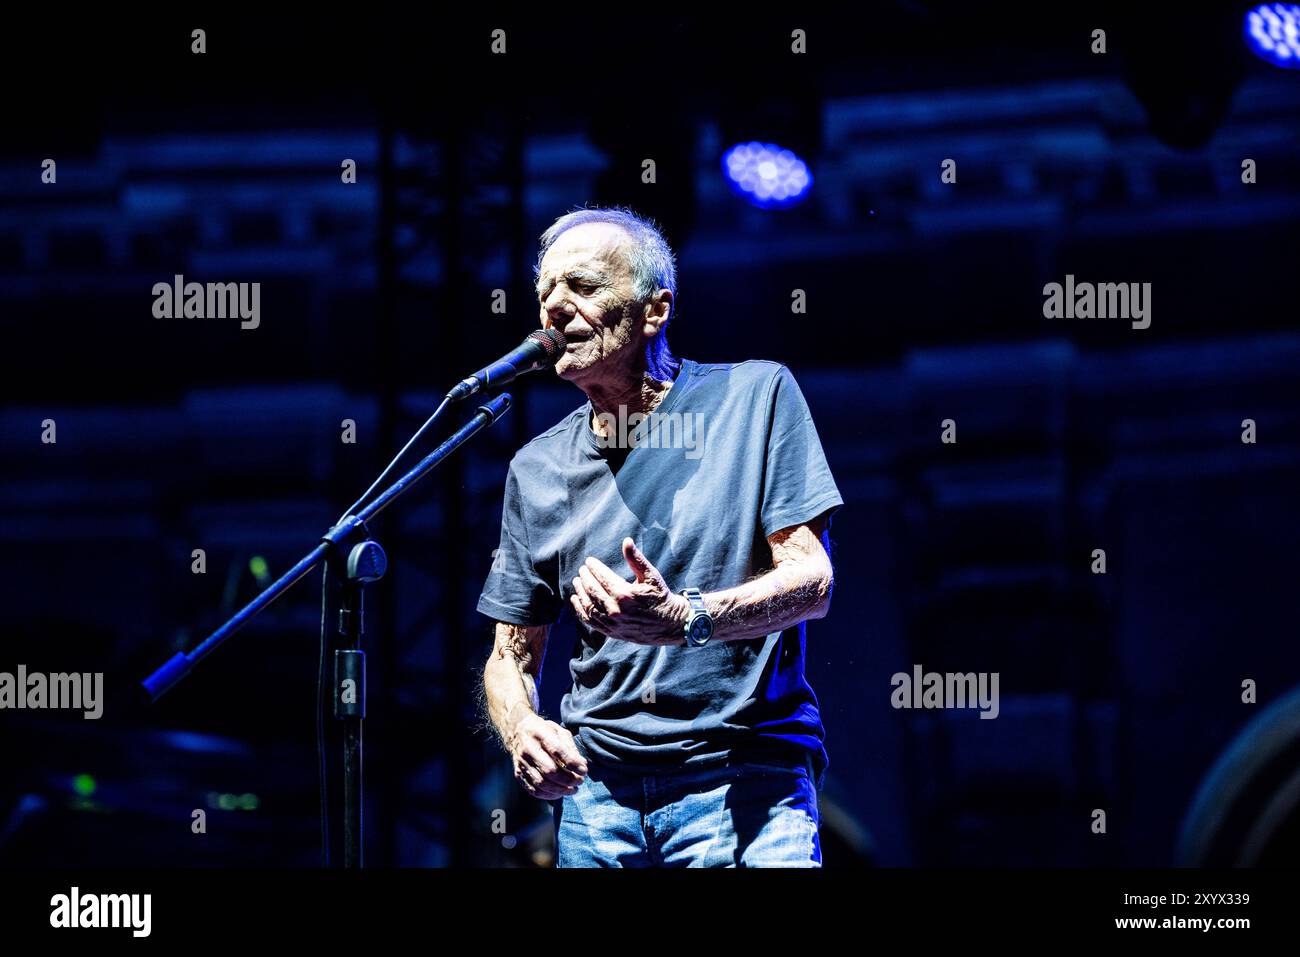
(537, 222), (642, 381)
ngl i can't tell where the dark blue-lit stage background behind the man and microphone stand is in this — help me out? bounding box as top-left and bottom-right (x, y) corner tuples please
(0, 3), (1300, 866)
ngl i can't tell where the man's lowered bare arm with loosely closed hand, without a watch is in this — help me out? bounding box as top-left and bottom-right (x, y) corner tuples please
(484, 622), (586, 801)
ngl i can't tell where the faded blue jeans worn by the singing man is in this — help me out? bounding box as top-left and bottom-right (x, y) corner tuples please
(553, 762), (822, 867)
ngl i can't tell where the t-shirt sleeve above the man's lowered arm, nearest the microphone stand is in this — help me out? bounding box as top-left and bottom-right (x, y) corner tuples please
(478, 462), (562, 625)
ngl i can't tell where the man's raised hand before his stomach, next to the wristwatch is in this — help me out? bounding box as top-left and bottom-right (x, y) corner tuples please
(569, 538), (690, 645)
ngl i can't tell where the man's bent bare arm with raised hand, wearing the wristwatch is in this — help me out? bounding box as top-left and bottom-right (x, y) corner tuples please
(571, 515), (835, 645)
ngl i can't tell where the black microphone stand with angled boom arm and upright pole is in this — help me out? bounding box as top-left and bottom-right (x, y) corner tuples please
(143, 393), (511, 867)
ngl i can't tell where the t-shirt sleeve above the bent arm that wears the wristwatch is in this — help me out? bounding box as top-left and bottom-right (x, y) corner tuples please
(762, 365), (844, 536)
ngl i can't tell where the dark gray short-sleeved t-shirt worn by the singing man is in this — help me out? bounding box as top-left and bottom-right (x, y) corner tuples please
(478, 360), (844, 780)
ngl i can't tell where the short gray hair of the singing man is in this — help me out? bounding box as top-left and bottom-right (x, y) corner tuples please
(533, 207), (681, 382)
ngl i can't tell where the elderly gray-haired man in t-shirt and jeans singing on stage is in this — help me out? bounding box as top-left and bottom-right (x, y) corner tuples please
(478, 209), (844, 867)
